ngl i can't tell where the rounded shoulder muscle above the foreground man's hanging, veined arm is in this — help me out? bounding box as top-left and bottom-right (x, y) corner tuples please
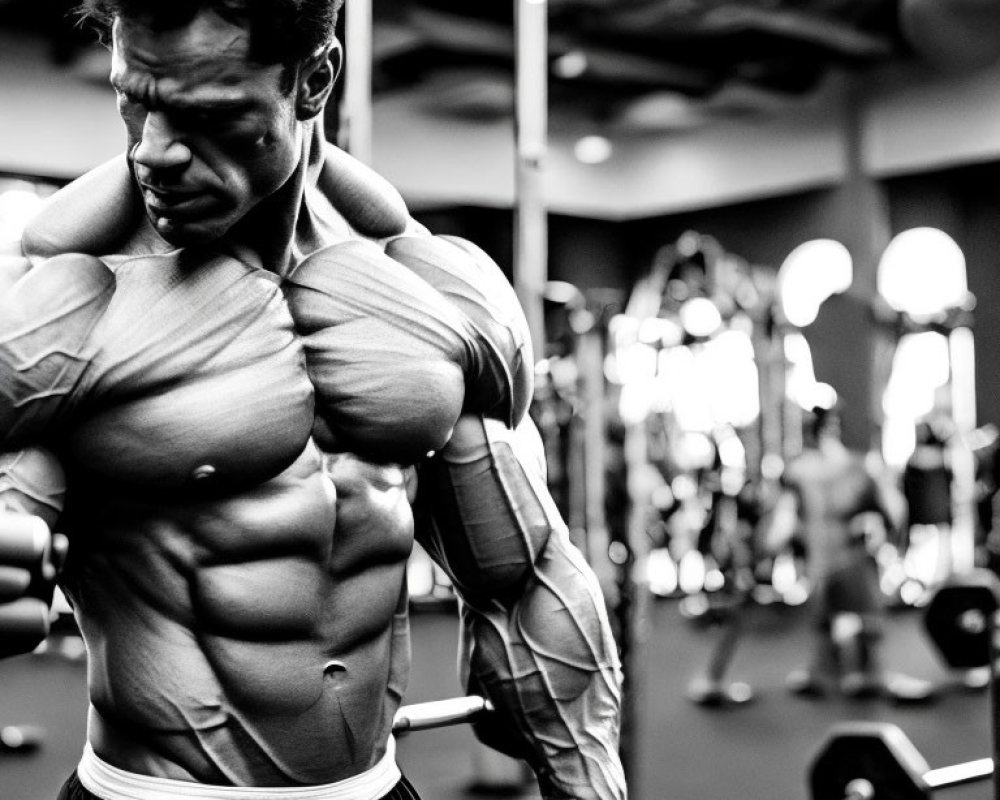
(385, 235), (534, 427)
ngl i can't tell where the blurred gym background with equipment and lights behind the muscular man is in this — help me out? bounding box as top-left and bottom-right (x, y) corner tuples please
(0, 0), (1000, 800)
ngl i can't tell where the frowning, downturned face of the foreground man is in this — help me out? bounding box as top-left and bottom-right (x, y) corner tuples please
(111, 12), (301, 245)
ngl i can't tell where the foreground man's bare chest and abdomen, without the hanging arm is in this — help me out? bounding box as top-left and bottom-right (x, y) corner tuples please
(5, 142), (476, 785)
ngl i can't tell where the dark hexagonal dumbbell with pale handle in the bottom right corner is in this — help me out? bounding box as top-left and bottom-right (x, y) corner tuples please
(808, 722), (993, 800)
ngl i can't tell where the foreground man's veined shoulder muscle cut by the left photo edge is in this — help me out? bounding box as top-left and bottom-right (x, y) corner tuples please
(0, 254), (114, 446)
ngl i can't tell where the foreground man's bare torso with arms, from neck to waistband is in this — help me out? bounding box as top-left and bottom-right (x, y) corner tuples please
(0, 120), (624, 797)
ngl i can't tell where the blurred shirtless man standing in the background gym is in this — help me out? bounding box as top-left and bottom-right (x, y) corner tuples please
(764, 408), (930, 700)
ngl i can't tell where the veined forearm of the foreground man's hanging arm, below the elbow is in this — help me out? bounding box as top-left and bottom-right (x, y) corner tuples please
(462, 531), (626, 800)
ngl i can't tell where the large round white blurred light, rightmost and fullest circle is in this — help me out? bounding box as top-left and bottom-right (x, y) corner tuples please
(877, 228), (968, 320)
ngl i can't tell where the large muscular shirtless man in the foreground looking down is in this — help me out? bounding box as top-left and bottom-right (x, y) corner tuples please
(0, 0), (625, 800)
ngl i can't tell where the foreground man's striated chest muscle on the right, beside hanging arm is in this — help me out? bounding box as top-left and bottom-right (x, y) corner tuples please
(284, 242), (475, 464)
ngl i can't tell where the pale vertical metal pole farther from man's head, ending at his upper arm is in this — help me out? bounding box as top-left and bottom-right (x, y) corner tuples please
(514, 0), (548, 357)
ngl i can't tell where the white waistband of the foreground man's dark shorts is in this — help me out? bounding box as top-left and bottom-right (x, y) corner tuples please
(77, 736), (401, 800)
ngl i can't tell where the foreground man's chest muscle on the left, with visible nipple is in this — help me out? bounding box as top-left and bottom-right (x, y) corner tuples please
(71, 252), (312, 487)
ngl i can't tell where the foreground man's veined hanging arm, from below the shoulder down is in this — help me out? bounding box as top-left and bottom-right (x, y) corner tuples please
(420, 417), (625, 800)
